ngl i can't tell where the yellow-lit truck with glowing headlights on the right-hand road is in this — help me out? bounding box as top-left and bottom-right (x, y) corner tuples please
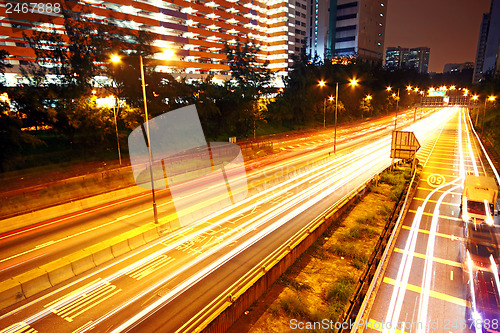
(461, 175), (498, 225)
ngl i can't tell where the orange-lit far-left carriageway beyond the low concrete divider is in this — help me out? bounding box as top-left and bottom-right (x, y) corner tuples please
(0, 112), (422, 281)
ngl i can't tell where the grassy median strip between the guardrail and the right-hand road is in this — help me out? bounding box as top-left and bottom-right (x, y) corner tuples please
(229, 167), (410, 333)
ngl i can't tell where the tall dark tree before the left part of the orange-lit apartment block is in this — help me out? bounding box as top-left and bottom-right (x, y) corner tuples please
(23, 11), (122, 98)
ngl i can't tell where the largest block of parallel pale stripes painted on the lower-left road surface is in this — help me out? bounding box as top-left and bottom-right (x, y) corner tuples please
(44, 282), (122, 322)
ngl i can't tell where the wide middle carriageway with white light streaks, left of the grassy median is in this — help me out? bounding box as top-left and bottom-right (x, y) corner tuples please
(0, 109), (456, 332)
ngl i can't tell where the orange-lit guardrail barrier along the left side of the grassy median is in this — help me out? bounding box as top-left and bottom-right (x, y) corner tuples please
(179, 162), (394, 333)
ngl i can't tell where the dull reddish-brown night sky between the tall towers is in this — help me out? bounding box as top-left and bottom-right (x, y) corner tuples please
(384, 0), (491, 73)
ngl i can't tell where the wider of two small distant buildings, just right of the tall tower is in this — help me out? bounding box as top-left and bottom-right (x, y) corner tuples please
(385, 46), (430, 74)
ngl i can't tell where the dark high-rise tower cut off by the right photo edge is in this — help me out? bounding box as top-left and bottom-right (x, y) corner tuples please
(473, 0), (500, 83)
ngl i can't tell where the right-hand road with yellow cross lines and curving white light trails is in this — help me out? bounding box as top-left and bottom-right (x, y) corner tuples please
(358, 110), (500, 333)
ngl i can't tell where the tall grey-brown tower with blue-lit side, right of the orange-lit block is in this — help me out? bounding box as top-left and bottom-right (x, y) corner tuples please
(306, 0), (387, 63)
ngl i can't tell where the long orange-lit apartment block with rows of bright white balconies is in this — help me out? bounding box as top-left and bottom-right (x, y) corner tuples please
(0, 0), (309, 84)
